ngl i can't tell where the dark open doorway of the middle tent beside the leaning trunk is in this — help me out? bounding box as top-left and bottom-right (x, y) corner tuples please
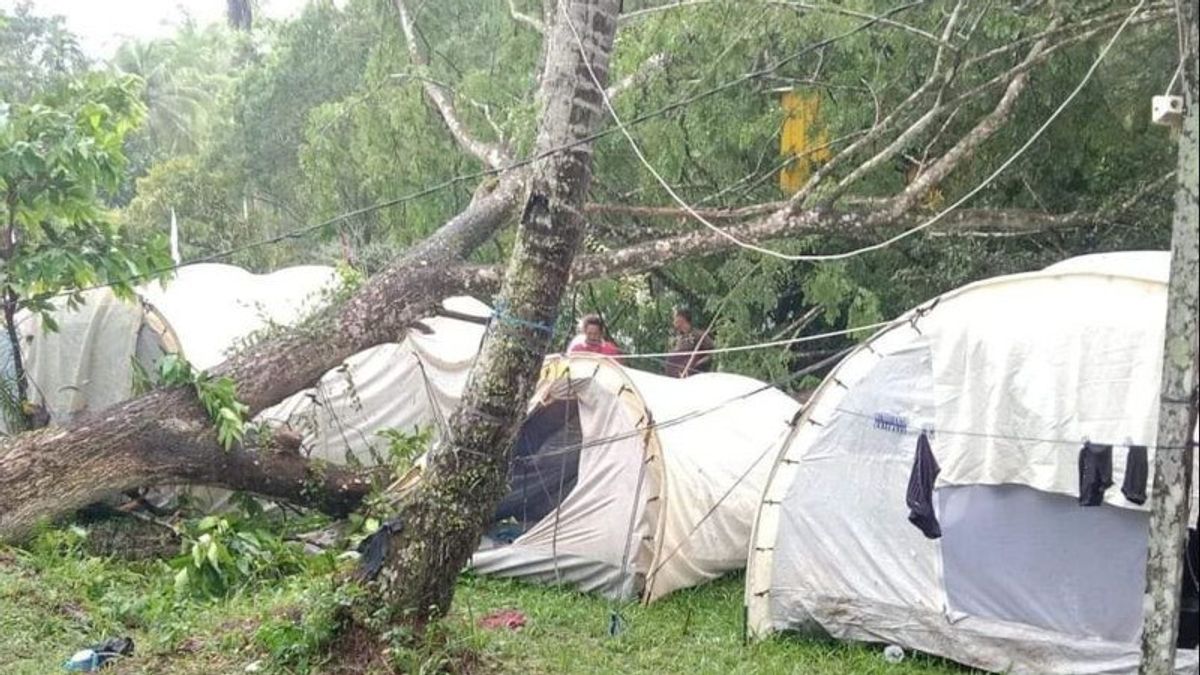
(492, 399), (583, 543)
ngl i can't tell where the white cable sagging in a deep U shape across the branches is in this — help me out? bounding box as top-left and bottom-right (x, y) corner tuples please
(564, 0), (1146, 262)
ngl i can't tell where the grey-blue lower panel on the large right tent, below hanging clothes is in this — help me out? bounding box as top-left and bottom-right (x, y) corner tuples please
(936, 485), (1148, 643)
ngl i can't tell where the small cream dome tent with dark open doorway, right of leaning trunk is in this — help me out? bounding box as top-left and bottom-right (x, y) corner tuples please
(472, 356), (799, 602)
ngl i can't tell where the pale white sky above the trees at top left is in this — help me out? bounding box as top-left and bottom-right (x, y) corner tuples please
(0, 0), (319, 59)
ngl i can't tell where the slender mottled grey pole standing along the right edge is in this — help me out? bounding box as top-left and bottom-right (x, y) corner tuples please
(1140, 0), (1200, 675)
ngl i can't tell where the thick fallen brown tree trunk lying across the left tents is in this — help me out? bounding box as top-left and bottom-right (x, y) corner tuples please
(0, 175), (522, 540)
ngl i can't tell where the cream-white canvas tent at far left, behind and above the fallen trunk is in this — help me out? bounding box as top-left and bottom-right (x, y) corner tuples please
(4, 264), (337, 424)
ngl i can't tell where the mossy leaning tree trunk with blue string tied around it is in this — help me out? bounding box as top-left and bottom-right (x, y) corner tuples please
(355, 0), (618, 628)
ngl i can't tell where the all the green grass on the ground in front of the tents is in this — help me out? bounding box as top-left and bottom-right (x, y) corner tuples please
(0, 521), (964, 675)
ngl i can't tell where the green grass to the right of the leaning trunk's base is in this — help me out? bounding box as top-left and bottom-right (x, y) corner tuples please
(455, 575), (964, 675)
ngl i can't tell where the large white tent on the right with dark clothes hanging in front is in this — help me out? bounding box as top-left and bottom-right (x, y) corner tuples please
(745, 252), (1198, 673)
